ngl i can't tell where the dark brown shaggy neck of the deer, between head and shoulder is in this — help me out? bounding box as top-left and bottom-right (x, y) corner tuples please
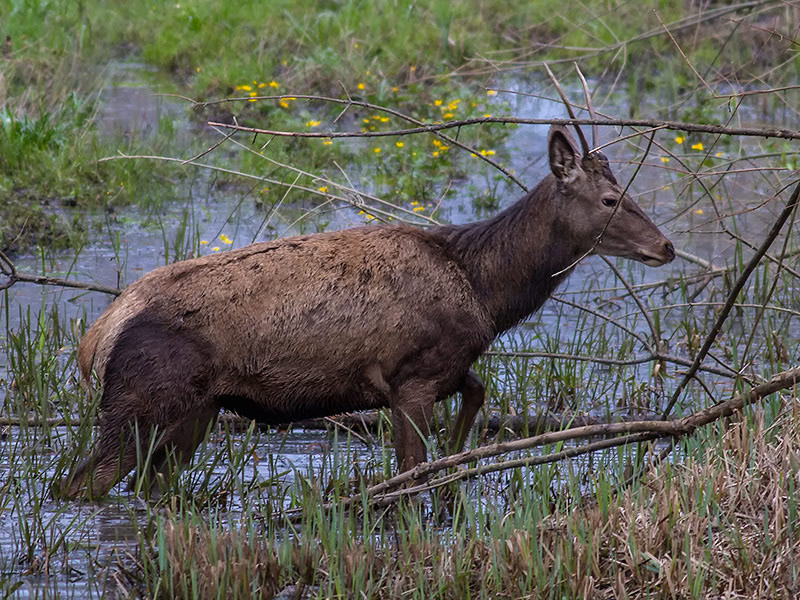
(438, 175), (586, 333)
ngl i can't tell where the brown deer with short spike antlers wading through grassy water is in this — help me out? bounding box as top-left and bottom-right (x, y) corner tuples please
(54, 126), (675, 497)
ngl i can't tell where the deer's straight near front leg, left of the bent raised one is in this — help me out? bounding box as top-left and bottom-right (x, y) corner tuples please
(391, 380), (436, 472)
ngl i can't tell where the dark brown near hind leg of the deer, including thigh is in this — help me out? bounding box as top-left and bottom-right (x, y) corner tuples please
(56, 318), (212, 498)
